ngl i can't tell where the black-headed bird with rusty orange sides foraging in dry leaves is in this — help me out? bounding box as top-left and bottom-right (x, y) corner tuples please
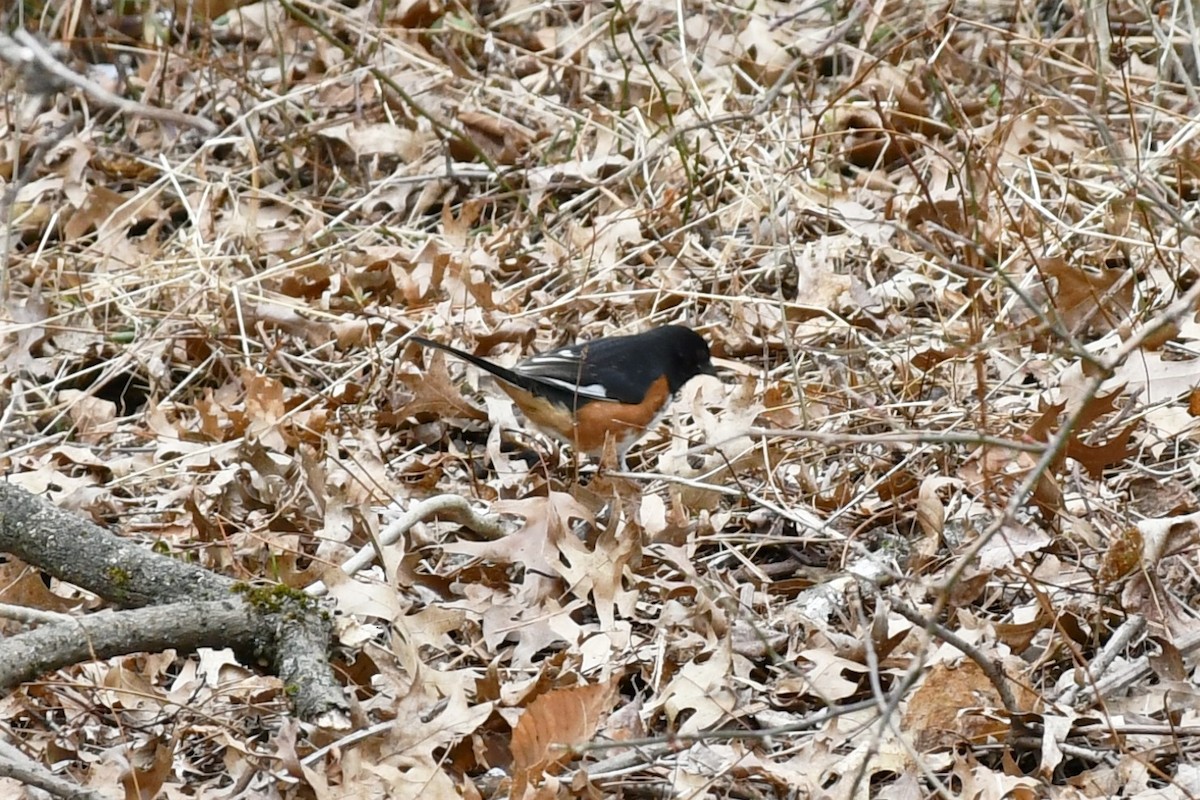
(408, 325), (716, 470)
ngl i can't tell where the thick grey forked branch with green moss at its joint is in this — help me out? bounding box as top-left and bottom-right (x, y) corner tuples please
(0, 482), (349, 728)
